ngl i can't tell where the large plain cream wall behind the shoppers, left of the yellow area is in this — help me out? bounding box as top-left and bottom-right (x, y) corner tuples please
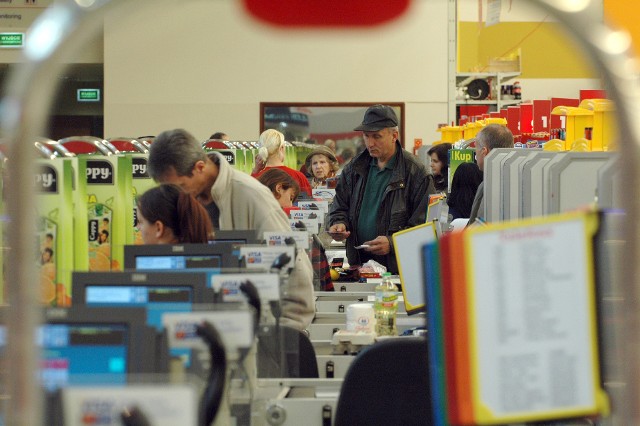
(104, 0), (447, 147)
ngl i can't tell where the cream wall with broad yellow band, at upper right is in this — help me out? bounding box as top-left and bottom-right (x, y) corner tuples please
(458, 0), (603, 99)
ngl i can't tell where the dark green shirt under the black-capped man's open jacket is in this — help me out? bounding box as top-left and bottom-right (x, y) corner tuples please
(356, 154), (396, 244)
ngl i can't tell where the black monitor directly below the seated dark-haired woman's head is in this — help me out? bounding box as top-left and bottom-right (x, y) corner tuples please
(124, 242), (239, 273)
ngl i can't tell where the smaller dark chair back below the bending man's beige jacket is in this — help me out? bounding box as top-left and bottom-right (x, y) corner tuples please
(256, 325), (319, 379)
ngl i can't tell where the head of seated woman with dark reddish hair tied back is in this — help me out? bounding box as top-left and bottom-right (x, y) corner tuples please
(138, 184), (213, 244)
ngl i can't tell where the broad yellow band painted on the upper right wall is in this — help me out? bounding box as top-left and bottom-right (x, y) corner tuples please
(458, 22), (597, 78)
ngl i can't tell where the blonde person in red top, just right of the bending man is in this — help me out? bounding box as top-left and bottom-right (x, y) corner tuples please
(251, 129), (311, 195)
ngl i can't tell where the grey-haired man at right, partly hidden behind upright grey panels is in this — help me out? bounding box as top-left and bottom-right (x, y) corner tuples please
(467, 124), (513, 226)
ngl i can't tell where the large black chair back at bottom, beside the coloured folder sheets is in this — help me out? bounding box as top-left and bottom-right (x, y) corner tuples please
(334, 337), (432, 426)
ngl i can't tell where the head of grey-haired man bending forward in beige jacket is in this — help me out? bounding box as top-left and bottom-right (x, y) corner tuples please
(148, 129), (210, 196)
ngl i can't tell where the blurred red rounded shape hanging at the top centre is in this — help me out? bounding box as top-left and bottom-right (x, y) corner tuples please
(243, 0), (411, 27)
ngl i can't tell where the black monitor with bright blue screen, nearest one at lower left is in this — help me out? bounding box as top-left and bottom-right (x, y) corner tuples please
(0, 306), (157, 391)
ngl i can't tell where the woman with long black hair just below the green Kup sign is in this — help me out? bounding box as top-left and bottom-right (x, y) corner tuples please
(447, 163), (483, 220)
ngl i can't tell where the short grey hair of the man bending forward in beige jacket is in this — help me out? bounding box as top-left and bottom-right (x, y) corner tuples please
(147, 129), (207, 182)
